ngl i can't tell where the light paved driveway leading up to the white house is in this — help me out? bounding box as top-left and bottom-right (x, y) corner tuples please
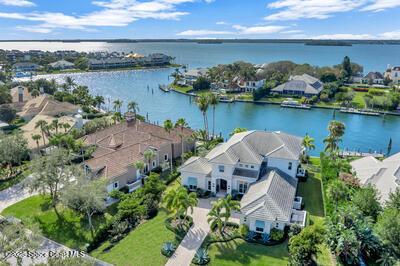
(165, 198), (239, 266)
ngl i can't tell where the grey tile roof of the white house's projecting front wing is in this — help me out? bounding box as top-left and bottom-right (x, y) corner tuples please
(240, 169), (297, 222)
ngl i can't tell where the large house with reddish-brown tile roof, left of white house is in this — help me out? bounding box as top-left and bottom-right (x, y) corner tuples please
(83, 115), (194, 197)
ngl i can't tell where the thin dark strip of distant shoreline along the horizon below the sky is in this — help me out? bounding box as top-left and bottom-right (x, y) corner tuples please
(0, 39), (400, 46)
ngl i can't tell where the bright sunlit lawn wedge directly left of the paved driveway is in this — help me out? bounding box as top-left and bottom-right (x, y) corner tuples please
(91, 210), (175, 266)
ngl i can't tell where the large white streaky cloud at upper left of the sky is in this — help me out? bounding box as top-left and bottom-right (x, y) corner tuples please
(0, 0), (209, 33)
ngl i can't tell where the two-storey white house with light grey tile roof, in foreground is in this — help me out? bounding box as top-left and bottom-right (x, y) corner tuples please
(180, 131), (306, 233)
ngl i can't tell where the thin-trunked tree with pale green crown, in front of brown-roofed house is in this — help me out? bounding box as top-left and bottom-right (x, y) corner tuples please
(61, 171), (108, 239)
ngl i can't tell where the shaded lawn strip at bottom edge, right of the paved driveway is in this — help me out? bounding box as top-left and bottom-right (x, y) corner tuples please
(209, 239), (289, 266)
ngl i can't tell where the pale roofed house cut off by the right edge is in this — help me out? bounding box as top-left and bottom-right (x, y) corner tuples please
(350, 153), (400, 204)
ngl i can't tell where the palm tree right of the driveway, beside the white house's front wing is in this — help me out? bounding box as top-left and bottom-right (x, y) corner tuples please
(207, 195), (240, 235)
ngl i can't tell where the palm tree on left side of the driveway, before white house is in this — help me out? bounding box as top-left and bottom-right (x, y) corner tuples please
(164, 186), (198, 228)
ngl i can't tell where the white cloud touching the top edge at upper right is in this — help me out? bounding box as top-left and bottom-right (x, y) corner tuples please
(264, 0), (369, 20)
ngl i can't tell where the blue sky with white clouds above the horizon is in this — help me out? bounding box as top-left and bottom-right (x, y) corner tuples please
(0, 0), (400, 39)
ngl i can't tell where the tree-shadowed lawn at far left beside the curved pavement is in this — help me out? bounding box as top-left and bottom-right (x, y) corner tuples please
(2, 195), (114, 249)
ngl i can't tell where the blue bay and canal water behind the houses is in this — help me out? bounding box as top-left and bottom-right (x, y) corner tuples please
(0, 42), (400, 154)
